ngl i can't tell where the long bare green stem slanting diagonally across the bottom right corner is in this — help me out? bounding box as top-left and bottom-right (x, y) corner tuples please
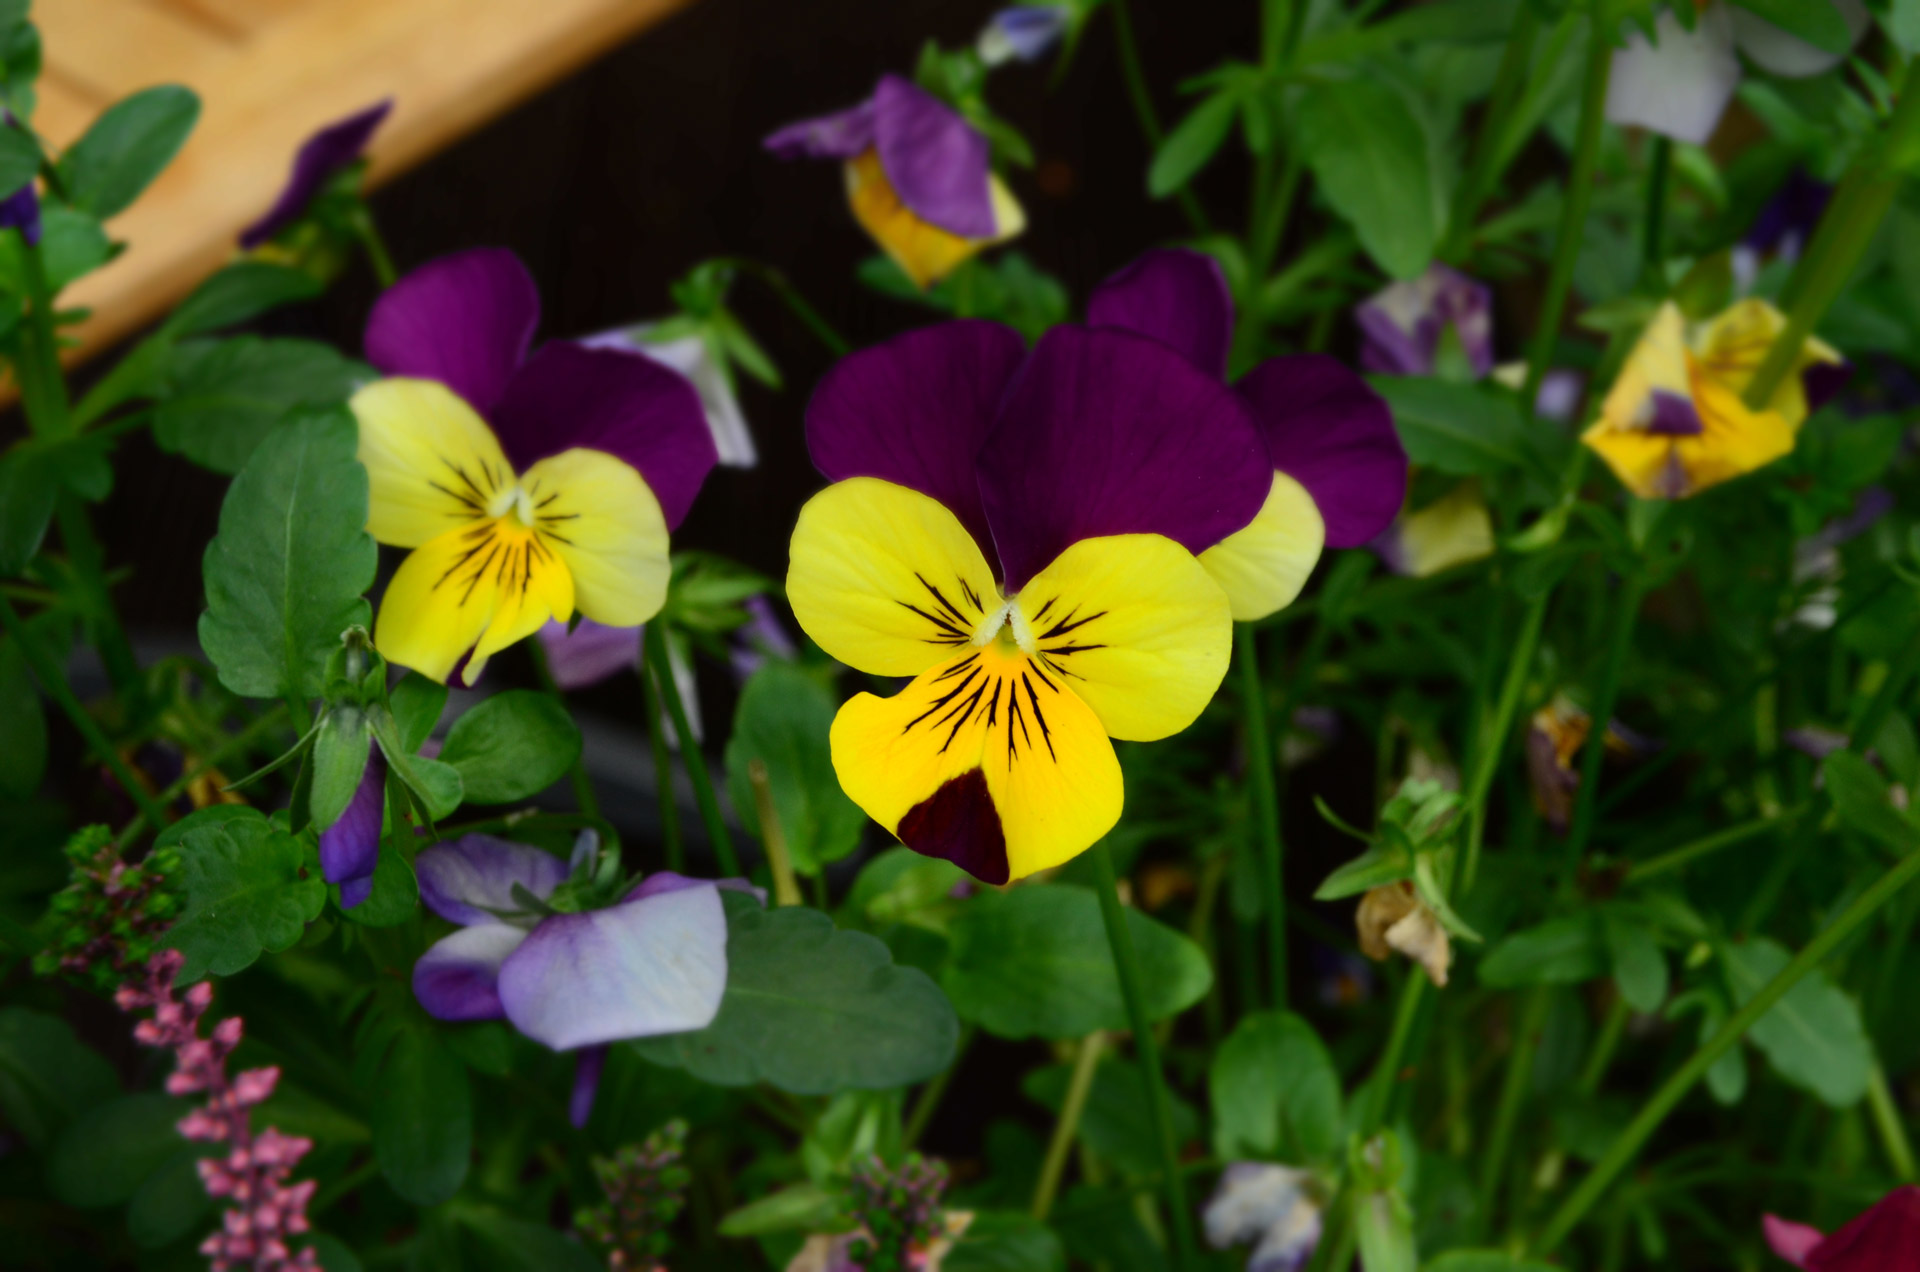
(1530, 851), (1920, 1255)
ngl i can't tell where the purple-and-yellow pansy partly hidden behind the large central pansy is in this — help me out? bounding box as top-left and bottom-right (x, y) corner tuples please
(1087, 250), (1407, 621)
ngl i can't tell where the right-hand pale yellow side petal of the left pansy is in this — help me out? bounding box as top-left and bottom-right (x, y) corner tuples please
(520, 448), (672, 626)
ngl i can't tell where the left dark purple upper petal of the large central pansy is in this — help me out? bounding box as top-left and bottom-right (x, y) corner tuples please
(806, 319), (1027, 557)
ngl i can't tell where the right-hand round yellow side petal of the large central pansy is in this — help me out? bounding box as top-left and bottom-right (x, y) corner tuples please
(1020, 534), (1233, 742)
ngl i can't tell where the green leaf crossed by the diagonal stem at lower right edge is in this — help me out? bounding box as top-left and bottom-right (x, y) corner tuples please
(1720, 938), (1874, 1109)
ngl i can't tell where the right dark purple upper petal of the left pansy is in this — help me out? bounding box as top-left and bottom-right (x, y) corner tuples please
(493, 340), (720, 530)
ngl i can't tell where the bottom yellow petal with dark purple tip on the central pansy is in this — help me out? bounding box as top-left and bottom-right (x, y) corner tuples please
(831, 640), (1123, 884)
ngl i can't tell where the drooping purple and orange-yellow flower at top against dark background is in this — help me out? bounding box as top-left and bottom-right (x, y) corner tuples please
(766, 75), (1027, 288)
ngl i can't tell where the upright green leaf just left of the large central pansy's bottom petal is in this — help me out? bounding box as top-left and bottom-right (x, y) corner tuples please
(726, 659), (866, 874)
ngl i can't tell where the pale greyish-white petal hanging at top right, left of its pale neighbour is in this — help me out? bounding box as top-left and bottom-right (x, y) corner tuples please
(1607, 4), (1740, 144)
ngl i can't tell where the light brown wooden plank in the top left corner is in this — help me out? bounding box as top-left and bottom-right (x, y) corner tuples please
(35, 0), (691, 359)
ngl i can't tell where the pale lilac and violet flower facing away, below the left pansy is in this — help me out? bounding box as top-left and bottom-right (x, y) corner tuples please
(413, 834), (728, 1124)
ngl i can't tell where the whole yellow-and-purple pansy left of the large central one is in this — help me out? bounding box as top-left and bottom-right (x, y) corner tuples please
(351, 248), (716, 684)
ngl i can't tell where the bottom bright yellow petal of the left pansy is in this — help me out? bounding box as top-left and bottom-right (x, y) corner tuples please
(374, 517), (574, 684)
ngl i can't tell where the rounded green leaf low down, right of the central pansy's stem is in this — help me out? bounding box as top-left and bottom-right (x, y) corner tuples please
(1208, 1011), (1342, 1161)
